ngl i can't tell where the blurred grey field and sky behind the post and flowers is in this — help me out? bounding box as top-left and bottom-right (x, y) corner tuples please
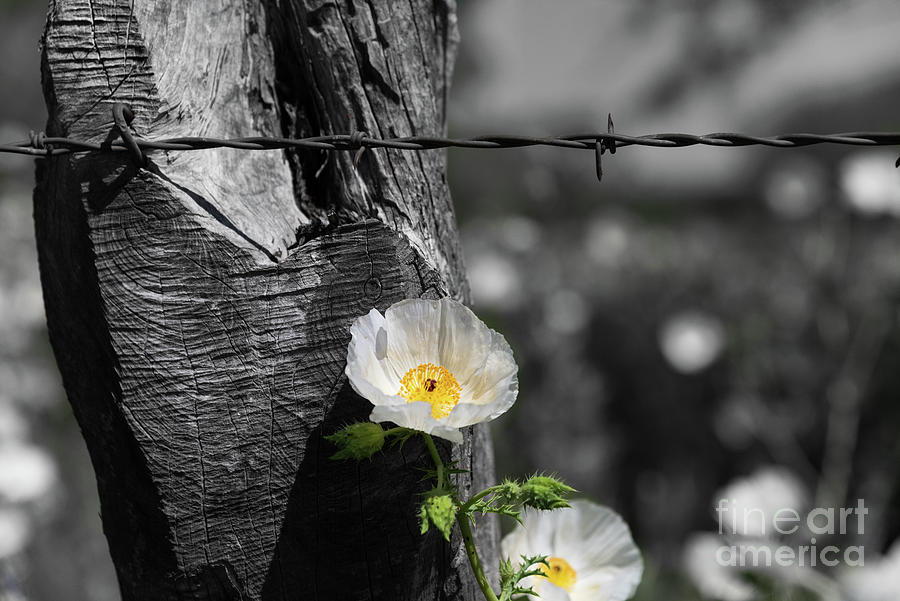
(0, 0), (900, 601)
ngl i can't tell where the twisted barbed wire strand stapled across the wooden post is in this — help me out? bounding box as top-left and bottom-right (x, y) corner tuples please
(0, 103), (900, 179)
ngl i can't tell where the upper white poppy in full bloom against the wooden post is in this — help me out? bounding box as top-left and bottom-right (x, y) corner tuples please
(345, 298), (519, 443)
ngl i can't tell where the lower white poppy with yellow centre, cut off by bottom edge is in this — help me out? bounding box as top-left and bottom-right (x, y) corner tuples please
(502, 500), (644, 601)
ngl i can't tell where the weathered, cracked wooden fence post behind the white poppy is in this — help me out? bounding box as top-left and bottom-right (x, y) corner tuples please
(35, 0), (496, 601)
